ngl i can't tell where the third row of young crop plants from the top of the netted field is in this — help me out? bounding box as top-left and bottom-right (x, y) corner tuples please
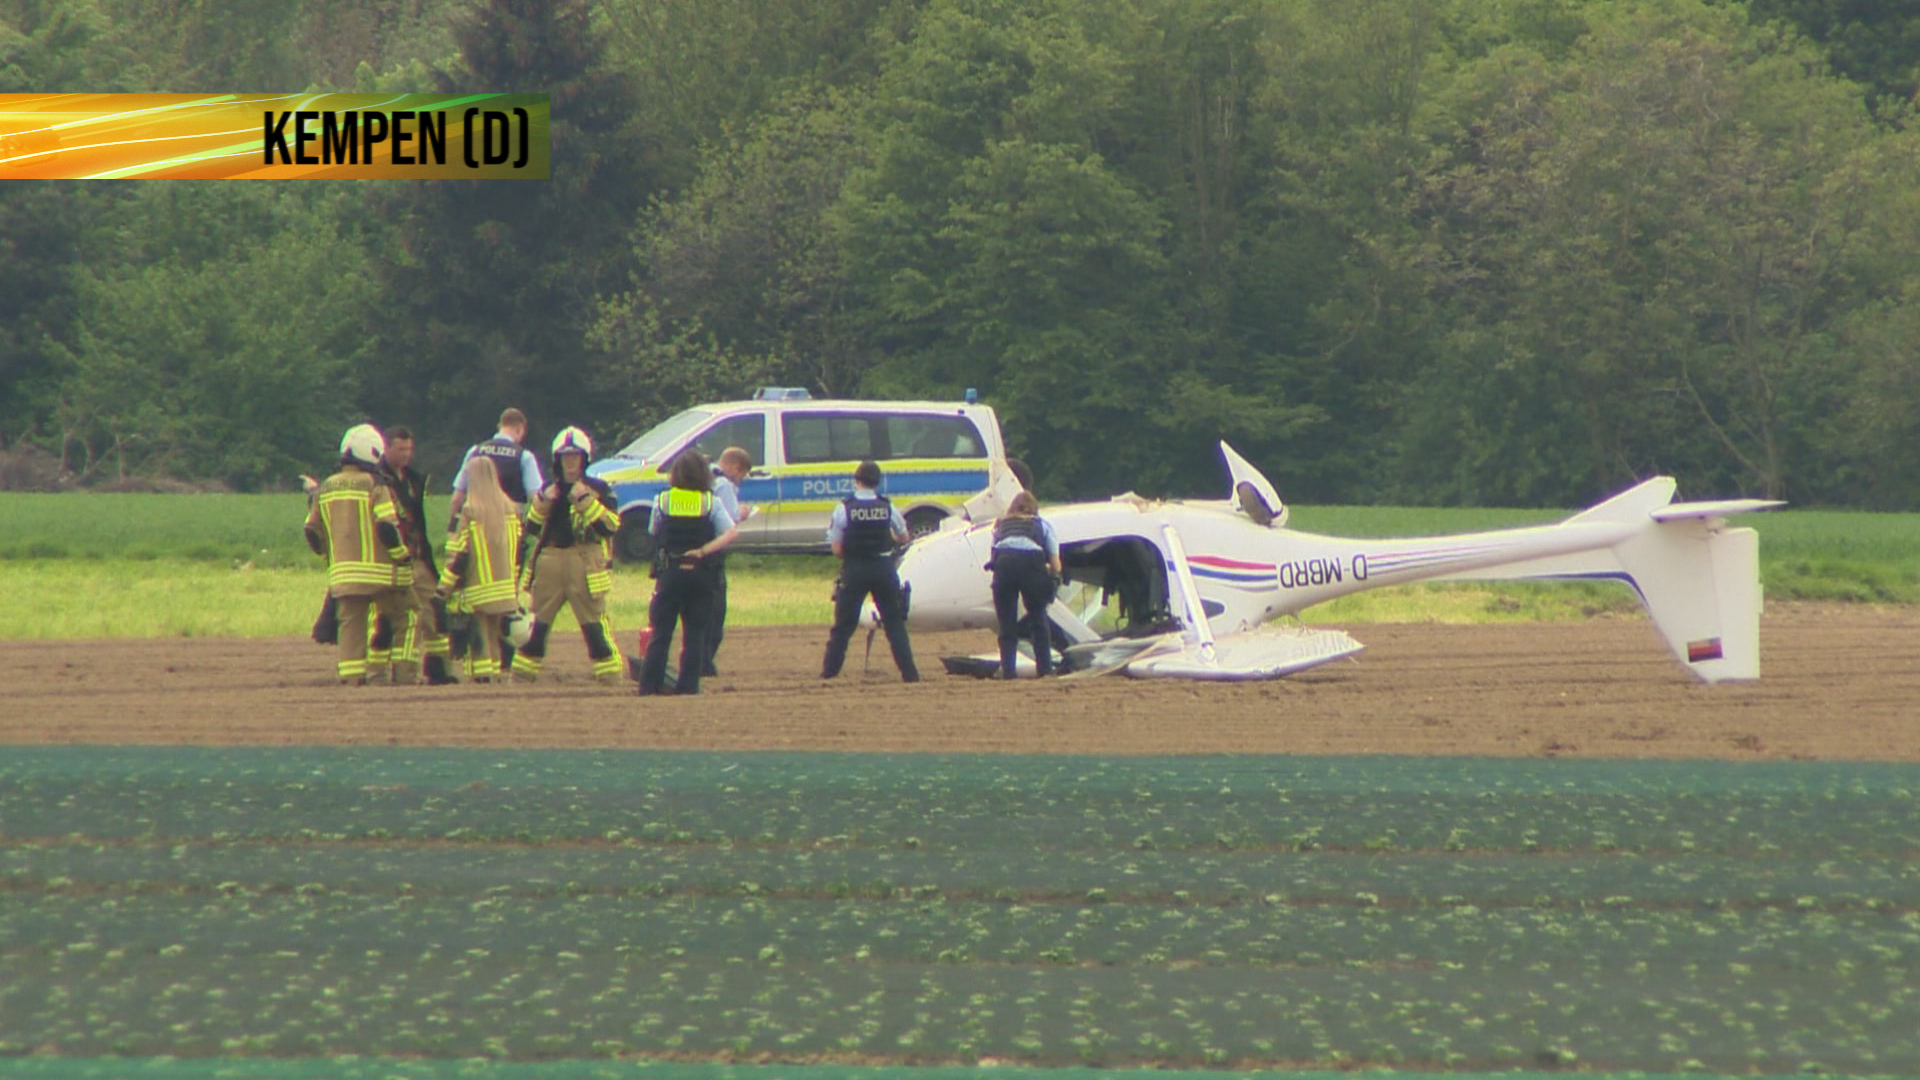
(0, 880), (1920, 972)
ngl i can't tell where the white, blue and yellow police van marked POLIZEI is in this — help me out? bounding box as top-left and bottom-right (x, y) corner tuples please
(588, 388), (1023, 561)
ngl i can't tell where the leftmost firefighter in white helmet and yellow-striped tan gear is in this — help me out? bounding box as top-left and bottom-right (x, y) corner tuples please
(305, 425), (413, 684)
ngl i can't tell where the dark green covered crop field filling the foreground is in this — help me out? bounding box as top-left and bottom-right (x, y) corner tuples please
(0, 748), (1920, 1080)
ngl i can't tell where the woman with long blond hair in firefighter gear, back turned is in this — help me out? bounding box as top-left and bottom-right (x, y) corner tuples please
(440, 454), (520, 682)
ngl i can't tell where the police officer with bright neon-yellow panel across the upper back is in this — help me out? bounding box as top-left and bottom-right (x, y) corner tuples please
(639, 450), (735, 696)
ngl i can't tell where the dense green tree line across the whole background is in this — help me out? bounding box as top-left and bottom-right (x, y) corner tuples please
(0, 0), (1920, 509)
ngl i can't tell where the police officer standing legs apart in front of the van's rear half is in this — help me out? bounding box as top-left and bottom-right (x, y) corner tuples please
(820, 461), (920, 682)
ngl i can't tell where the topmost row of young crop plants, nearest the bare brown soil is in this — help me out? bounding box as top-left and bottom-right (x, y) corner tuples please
(15, 767), (1920, 855)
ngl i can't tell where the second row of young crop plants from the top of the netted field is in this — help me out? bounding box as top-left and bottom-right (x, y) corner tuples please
(0, 842), (1920, 911)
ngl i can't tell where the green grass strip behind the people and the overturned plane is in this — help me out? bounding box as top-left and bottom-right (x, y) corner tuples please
(0, 494), (1920, 640)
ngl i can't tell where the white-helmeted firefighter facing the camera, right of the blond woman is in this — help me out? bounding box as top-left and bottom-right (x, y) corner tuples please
(513, 427), (626, 684)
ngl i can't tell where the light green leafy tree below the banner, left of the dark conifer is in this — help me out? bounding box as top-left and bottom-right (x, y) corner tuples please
(54, 184), (374, 490)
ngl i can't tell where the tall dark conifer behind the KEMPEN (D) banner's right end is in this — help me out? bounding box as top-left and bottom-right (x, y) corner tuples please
(378, 0), (641, 471)
